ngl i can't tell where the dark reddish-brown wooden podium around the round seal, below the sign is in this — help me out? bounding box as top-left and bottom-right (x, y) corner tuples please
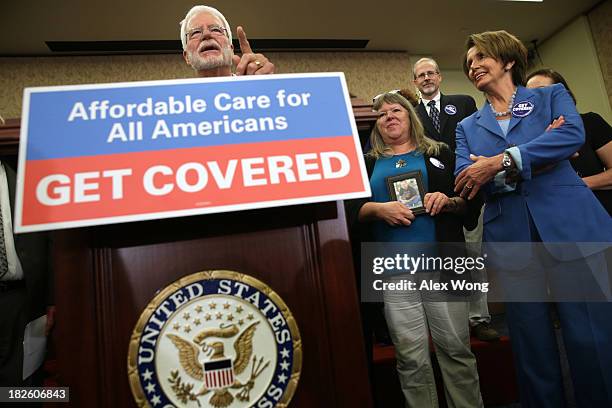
(0, 97), (372, 408)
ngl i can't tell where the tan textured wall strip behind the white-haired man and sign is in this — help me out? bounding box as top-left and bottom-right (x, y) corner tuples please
(0, 52), (411, 118)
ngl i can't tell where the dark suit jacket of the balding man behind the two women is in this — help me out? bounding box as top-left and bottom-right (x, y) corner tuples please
(417, 94), (476, 153)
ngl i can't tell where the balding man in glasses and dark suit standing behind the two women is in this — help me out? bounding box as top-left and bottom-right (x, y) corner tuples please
(412, 58), (499, 341)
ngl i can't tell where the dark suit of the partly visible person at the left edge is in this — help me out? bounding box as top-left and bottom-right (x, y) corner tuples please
(0, 157), (52, 386)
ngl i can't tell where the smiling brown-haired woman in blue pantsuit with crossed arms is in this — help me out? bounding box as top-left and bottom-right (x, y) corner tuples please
(455, 31), (612, 408)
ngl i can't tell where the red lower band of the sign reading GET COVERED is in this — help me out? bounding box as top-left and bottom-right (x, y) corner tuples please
(22, 136), (367, 226)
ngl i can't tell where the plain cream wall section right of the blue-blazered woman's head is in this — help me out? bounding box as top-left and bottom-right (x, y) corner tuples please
(538, 16), (612, 123)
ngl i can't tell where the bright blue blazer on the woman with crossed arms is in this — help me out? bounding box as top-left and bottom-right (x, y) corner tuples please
(455, 84), (612, 259)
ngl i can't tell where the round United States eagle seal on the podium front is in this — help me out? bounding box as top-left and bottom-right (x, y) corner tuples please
(128, 270), (302, 408)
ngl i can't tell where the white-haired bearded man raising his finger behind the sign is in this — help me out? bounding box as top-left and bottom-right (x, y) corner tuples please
(180, 6), (274, 77)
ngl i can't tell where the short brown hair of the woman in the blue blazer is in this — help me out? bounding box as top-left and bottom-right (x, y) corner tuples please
(463, 30), (527, 85)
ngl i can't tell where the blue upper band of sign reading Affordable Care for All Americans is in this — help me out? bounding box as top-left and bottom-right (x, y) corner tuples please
(27, 76), (352, 160)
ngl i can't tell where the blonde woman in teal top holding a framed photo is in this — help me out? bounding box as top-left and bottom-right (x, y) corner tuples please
(347, 93), (482, 408)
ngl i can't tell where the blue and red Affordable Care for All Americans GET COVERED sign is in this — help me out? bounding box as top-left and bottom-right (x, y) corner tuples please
(15, 73), (370, 232)
